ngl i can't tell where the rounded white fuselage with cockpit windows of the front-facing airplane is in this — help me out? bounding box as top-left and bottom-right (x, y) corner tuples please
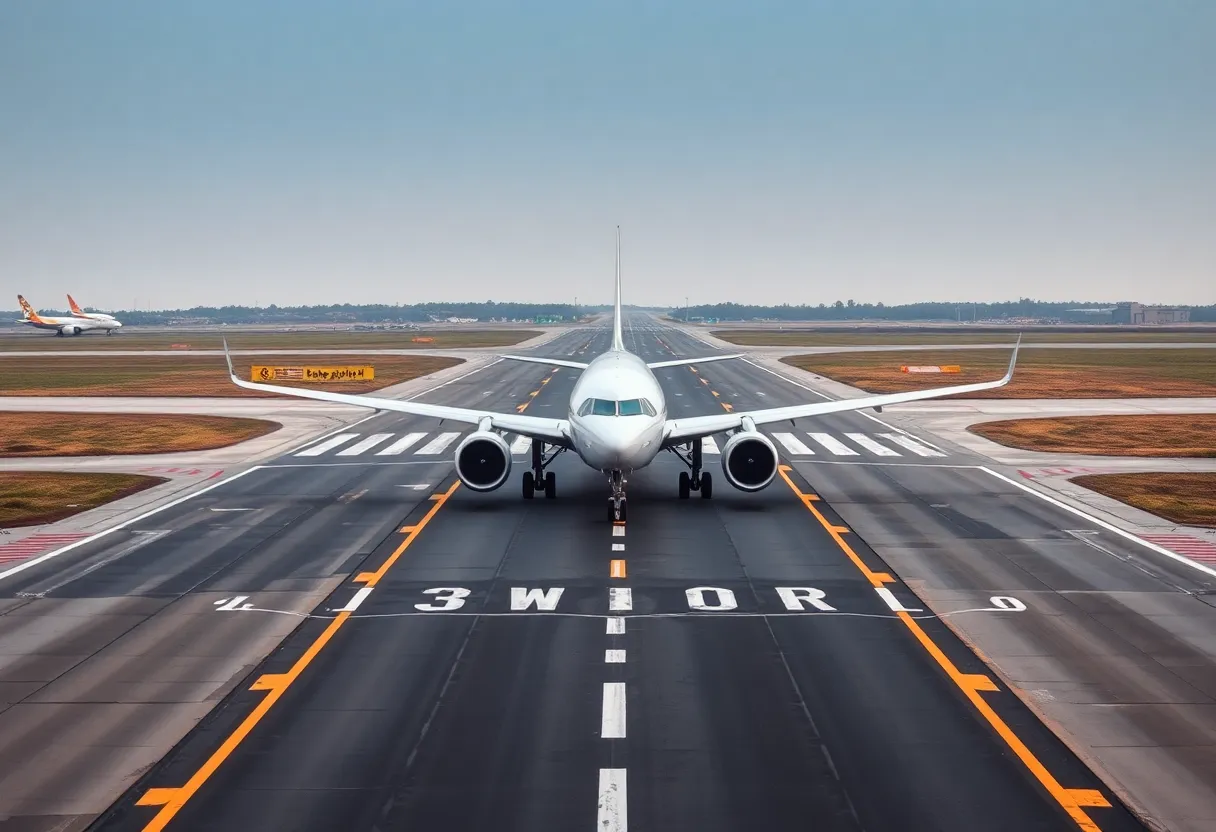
(569, 350), (668, 473)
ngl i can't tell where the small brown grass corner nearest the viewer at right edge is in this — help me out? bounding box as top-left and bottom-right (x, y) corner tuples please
(1071, 472), (1216, 527)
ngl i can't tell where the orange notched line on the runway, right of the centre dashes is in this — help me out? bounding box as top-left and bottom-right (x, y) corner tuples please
(777, 465), (1110, 832)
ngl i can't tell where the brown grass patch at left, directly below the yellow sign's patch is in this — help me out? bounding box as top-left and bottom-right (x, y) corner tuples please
(0, 411), (281, 457)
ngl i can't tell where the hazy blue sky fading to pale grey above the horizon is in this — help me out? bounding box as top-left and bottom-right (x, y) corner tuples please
(0, 0), (1216, 308)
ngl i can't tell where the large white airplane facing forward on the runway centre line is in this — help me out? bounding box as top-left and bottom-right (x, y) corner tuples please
(224, 227), (1021, 521)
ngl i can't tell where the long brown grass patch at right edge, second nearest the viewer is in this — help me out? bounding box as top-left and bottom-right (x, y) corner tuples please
(968, 414), (1216, 456)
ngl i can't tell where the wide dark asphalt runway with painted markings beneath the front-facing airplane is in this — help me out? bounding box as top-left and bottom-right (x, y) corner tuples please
(0, 317), (1216, 832)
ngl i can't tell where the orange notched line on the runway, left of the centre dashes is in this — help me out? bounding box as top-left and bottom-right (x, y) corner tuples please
(136, 480), (460, 832)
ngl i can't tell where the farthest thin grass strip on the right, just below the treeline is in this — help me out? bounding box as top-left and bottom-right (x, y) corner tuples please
(710, 328), (1216, 347)
